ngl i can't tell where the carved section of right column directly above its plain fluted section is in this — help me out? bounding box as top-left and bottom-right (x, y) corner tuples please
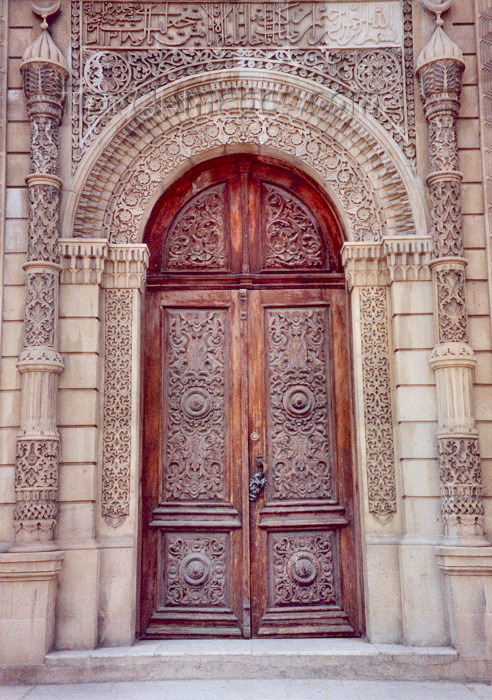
(436, 268), (468, 343)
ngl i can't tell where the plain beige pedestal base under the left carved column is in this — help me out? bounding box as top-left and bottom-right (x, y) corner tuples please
(0, 551), (63, 665)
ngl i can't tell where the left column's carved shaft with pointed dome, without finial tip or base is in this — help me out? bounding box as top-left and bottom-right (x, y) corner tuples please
(14, 29), (67, 548)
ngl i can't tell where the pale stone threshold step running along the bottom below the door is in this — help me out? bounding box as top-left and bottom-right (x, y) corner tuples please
(0, 639), (492, 684)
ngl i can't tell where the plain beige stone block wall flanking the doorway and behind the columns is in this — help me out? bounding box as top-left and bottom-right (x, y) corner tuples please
(0, 0), (492, 648)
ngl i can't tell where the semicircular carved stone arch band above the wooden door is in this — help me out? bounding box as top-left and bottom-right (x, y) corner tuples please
(64, 71), (426, 243)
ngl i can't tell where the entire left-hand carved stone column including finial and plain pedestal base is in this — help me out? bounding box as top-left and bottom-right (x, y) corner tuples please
(0, 1), (68, 663)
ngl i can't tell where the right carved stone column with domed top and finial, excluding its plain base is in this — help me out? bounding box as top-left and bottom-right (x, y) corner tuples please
(417, 0), (484, 543)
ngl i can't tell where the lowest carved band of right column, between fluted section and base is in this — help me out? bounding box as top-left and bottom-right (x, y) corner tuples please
(438, 435), (484, 527)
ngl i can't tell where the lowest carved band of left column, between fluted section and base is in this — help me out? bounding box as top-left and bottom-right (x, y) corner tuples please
(14, 440), (59, 533)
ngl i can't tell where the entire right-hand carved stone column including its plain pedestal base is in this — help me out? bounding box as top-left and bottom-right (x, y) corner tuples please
(417, 0), (492, 658)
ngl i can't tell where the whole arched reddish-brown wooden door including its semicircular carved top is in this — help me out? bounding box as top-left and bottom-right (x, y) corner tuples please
(140, 154), (360, 637)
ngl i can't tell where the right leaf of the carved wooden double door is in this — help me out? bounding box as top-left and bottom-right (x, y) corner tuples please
(249, 289), (356, 636)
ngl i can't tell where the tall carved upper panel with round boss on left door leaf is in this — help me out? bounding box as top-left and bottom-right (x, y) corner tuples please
(163, 310), (228, 500)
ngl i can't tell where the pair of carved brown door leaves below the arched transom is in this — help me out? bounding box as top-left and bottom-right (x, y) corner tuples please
(140, 156), (360, 637)
